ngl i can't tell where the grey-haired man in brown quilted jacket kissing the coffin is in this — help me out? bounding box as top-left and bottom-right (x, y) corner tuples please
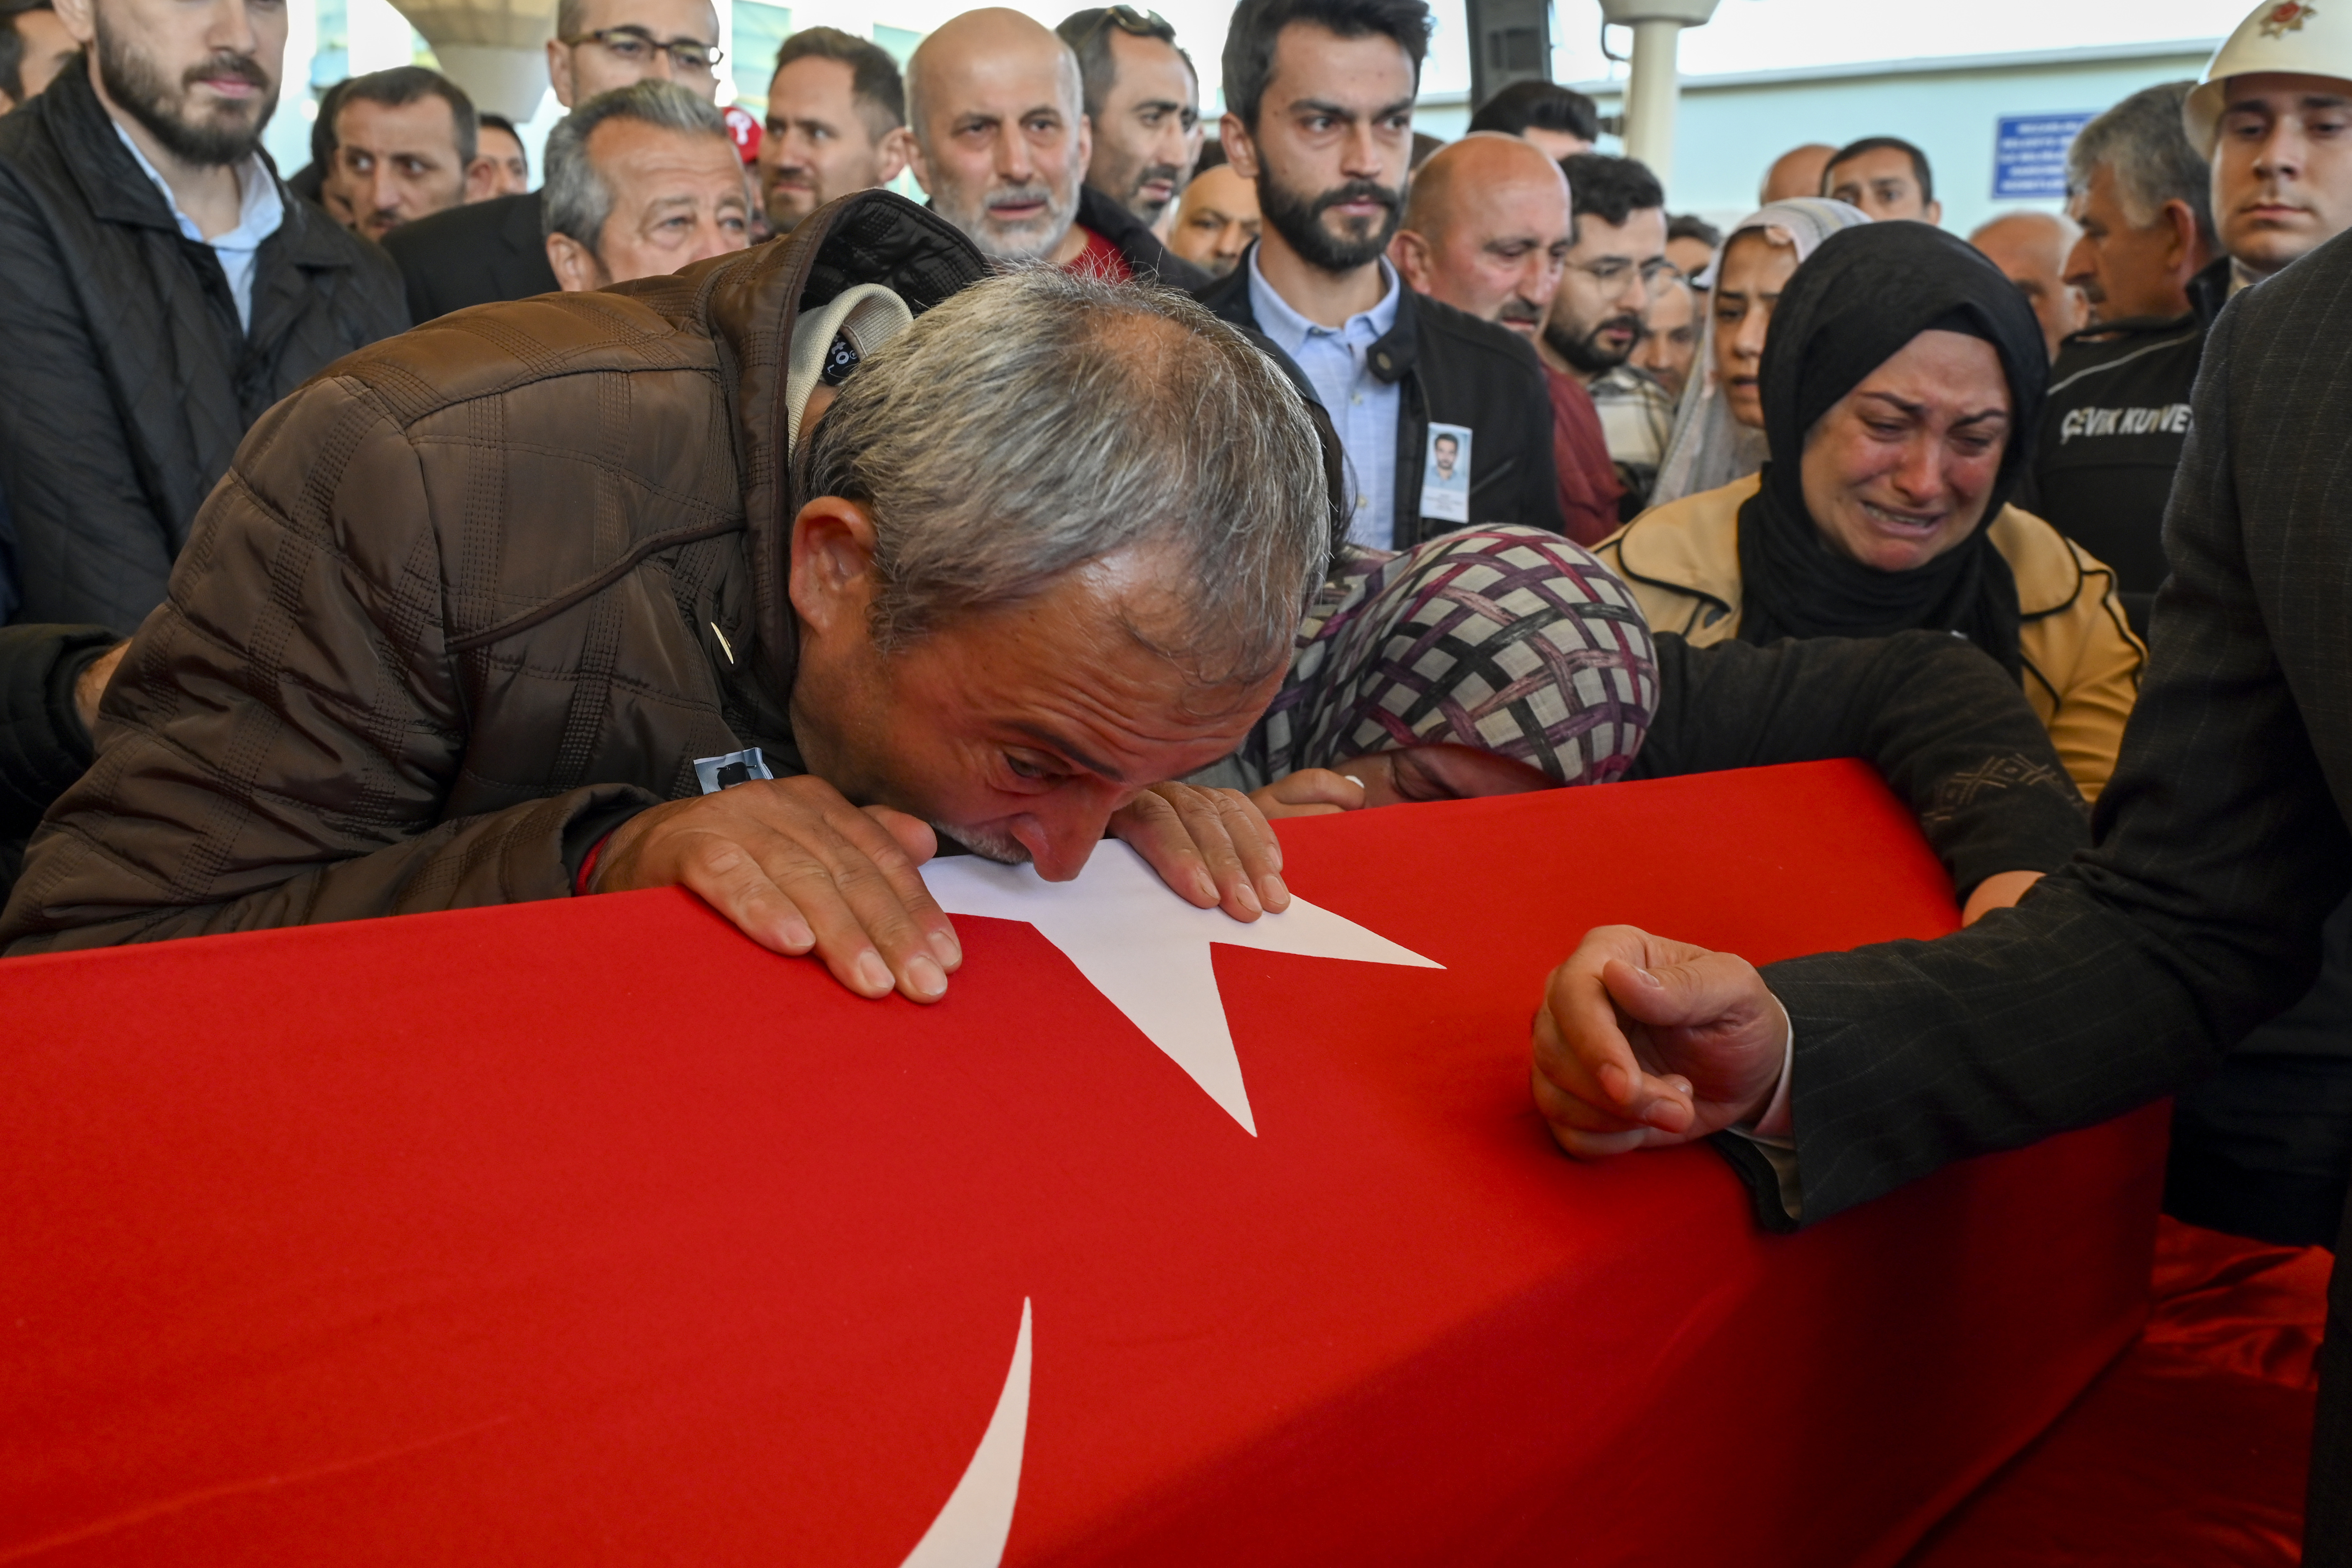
(0, 193), (1331, 1001)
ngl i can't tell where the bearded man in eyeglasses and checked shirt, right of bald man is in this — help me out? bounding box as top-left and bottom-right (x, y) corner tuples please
(1536, 153), (1675, 520)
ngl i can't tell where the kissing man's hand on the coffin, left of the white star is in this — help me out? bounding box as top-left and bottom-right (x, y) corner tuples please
(593, 774), (964, 1001)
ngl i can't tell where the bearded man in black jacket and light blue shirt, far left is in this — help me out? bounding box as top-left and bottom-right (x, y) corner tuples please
(0, 0), (407, 635)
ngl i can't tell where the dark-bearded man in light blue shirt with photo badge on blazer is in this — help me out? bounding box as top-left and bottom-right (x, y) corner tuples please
(1202, 0), (1564, 550)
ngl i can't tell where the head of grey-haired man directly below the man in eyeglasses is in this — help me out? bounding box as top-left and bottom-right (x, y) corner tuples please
(543, 80), (750, 294)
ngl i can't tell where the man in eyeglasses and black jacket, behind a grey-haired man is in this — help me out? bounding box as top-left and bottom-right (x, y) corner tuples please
(383, 0), (720, 322)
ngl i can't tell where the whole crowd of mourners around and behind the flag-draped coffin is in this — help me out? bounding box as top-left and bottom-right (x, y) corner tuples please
(0, 0), (2352, 1563)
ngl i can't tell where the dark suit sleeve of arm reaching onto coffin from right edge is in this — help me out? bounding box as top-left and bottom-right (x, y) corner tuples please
(1764, 291), (2352, 1223)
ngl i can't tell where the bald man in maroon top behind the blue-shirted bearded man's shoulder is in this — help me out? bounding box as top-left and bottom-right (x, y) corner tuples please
(1388, 132), (1623, 545)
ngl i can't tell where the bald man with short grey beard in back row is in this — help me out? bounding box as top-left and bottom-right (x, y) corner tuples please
(906, 7), (1209, 289)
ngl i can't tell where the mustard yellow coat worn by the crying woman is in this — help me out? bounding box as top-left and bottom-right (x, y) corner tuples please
(1595, 475), (2148, 799)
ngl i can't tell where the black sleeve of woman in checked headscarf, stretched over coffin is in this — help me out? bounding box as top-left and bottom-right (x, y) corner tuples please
(1632, 632), (2091, 900)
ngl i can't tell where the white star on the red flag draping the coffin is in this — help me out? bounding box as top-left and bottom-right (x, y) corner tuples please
(922, 839), (1444, 1138)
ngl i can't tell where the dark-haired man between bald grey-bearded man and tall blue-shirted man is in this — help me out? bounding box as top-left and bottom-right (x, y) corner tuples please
(1054, 5), (1209, 268)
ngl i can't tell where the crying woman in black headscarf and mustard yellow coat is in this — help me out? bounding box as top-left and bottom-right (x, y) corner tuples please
(1599, 223), (2148, 799)
